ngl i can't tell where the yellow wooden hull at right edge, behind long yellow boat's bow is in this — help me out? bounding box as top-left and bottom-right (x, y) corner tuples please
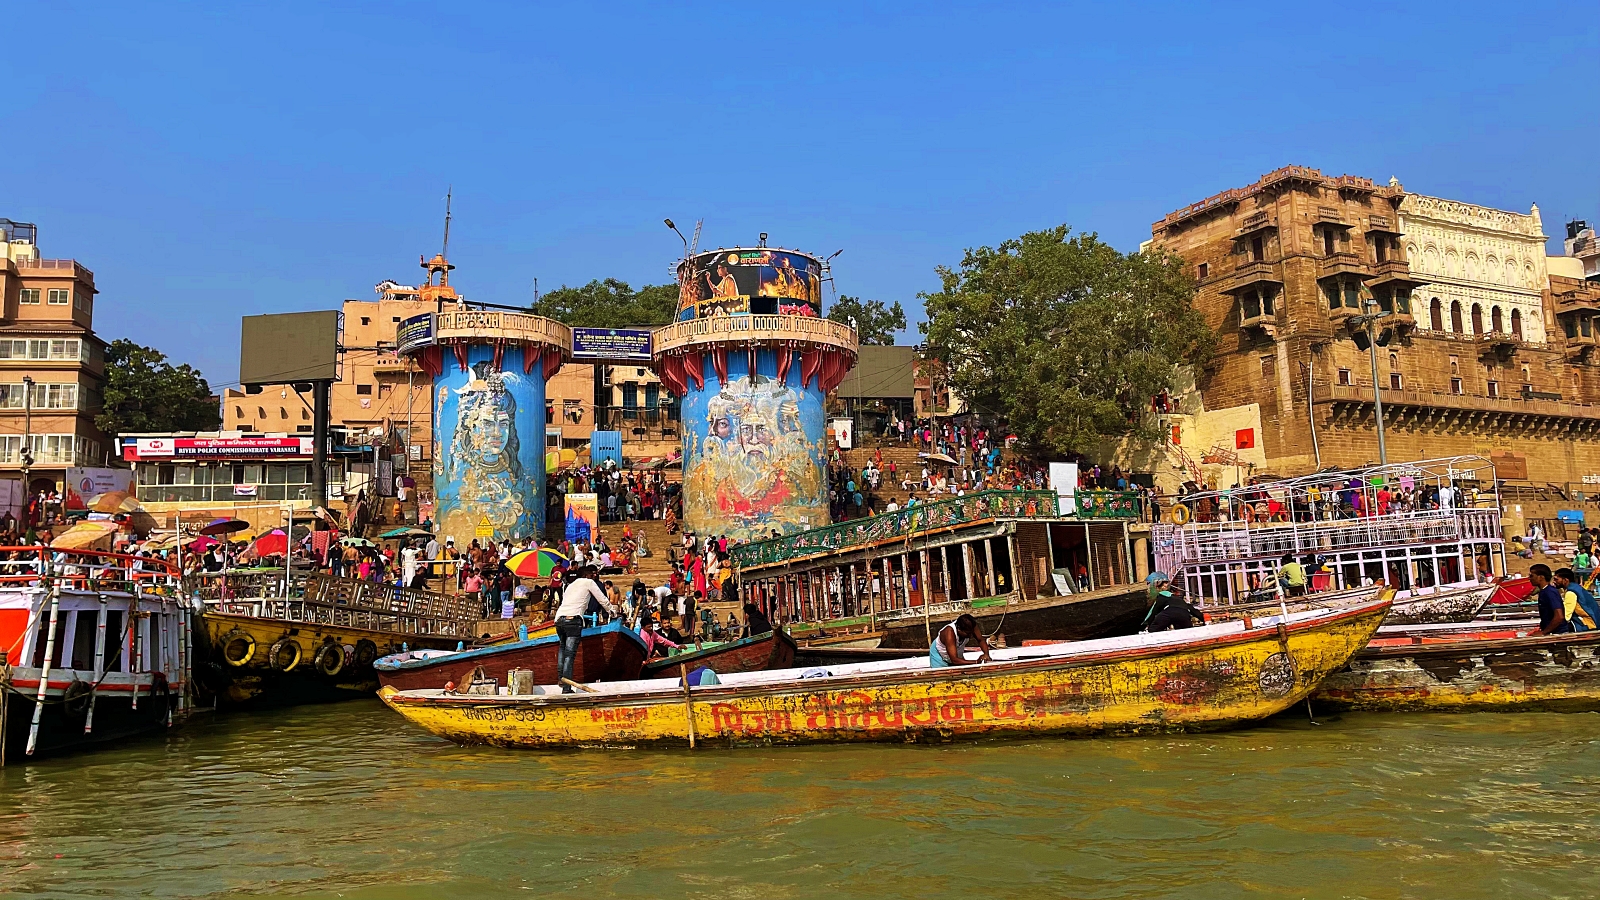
(1312, 631), (1600, 713)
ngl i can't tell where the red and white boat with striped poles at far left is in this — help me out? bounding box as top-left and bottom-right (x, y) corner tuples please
(0, 546), (192, 762)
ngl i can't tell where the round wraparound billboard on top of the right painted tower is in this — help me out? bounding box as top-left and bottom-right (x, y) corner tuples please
(678, 247), (822, 320)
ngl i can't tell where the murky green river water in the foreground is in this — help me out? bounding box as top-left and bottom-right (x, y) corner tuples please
(0, 701), (1600, 900)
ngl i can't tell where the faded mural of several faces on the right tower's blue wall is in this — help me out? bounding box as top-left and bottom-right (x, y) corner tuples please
(683, 366), (827, 538)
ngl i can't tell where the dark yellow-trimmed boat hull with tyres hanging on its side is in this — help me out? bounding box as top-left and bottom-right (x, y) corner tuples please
(195, 612), (459, 709)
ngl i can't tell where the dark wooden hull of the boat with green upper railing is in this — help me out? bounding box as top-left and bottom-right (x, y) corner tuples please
(878, 586), (1150, 650)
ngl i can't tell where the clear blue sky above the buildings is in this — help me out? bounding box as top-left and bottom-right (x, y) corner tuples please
(0, 0), (1600, 388)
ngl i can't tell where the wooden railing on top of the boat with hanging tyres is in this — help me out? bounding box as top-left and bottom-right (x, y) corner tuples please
(197, 573), (480, 637)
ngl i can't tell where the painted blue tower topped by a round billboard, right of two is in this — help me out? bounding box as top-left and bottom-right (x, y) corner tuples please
(653, 243), (856, 540)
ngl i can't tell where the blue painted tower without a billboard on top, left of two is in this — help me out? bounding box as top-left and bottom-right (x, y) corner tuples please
(395, 259), (573, 548)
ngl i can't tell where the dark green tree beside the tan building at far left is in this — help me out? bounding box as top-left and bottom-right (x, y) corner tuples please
(94, 338), (222, 434)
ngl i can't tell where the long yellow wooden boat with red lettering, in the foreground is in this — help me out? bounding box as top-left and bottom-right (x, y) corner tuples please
(379, 597), (1389, 748)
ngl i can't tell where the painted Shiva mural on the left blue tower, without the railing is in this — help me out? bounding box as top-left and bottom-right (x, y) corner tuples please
(435, 355), (544, 546)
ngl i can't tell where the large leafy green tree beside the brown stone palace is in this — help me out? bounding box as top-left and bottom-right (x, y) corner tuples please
(922, 226), (1213, 453)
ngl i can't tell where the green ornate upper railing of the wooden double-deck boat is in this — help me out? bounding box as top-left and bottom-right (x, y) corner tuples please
(733, 490), (1139, 569)
